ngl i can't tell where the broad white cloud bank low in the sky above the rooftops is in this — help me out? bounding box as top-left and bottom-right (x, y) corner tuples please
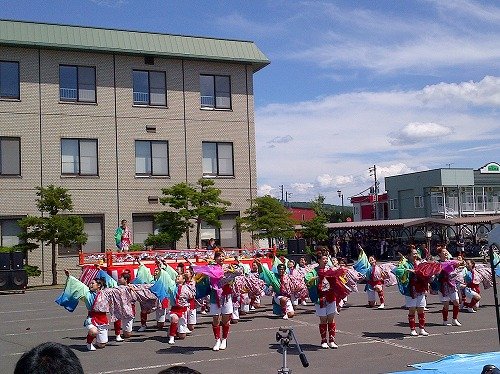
(256, 76), (500, 203)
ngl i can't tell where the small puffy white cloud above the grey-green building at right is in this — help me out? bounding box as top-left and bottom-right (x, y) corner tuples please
(389, 122), (453, 145)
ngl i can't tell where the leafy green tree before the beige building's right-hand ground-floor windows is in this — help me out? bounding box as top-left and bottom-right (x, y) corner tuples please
(160, 178), (231, 248)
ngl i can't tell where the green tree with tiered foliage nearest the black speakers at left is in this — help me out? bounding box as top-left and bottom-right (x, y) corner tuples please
(19, 185), (87, 285)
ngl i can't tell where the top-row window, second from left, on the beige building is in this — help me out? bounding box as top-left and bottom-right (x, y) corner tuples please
(59, 65), (96, 103)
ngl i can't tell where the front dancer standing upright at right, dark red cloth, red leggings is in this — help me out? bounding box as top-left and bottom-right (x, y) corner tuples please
(392, 248), (441, 336)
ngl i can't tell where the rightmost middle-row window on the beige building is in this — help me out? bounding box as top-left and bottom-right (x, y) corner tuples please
(203, 142), (234, 176)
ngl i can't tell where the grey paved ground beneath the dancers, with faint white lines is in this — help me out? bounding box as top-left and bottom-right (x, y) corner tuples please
(0, 287), (499, 374)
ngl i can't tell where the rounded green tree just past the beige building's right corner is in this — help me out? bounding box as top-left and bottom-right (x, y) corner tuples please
(237, 195), (294, 246)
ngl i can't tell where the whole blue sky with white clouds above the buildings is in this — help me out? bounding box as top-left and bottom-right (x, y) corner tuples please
(0, 0), (500, 204)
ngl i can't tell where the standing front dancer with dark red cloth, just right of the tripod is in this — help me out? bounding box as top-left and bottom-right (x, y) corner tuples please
(305, 254), (349, 349)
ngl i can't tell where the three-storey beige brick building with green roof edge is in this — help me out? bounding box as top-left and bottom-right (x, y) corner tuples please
(0, 20), (269, 283)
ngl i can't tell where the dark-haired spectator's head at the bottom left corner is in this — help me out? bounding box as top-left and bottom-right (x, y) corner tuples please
(14, 342), (83, 374)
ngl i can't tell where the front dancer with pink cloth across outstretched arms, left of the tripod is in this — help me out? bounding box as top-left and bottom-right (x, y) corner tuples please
(193, 251), (241, 351)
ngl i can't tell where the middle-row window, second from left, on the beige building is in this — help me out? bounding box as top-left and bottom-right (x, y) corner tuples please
(61, 139), (98, 175)
